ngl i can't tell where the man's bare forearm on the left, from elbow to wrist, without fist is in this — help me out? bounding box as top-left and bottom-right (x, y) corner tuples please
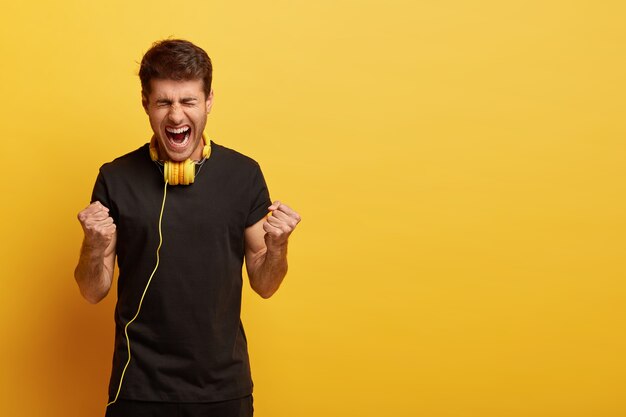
(74, 241), (113, 304)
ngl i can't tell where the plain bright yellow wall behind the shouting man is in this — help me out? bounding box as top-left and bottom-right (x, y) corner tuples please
(0, 0), (626, 417)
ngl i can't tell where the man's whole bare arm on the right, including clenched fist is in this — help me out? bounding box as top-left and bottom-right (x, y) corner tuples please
(244, 201), (301, 298)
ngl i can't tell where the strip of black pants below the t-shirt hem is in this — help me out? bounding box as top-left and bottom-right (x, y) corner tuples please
(105, 395), (254, 417)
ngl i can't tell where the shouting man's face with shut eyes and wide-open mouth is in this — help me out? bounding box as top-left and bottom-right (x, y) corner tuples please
(142, 79), (213, 162)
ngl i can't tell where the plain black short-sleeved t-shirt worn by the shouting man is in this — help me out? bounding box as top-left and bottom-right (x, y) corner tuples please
(92, 143), (271, 402)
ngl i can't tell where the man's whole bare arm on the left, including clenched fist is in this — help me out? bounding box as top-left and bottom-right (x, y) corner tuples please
(74, 201), (117, 304)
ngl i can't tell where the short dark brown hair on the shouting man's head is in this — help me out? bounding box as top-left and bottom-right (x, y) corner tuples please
(139, 39), (213, 97)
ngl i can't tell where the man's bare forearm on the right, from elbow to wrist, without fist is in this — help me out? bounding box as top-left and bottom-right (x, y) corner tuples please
(249, 243), (287, 298)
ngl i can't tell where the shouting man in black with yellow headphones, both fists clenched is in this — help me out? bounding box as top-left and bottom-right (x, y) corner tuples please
(74, 40), (300, 417)
